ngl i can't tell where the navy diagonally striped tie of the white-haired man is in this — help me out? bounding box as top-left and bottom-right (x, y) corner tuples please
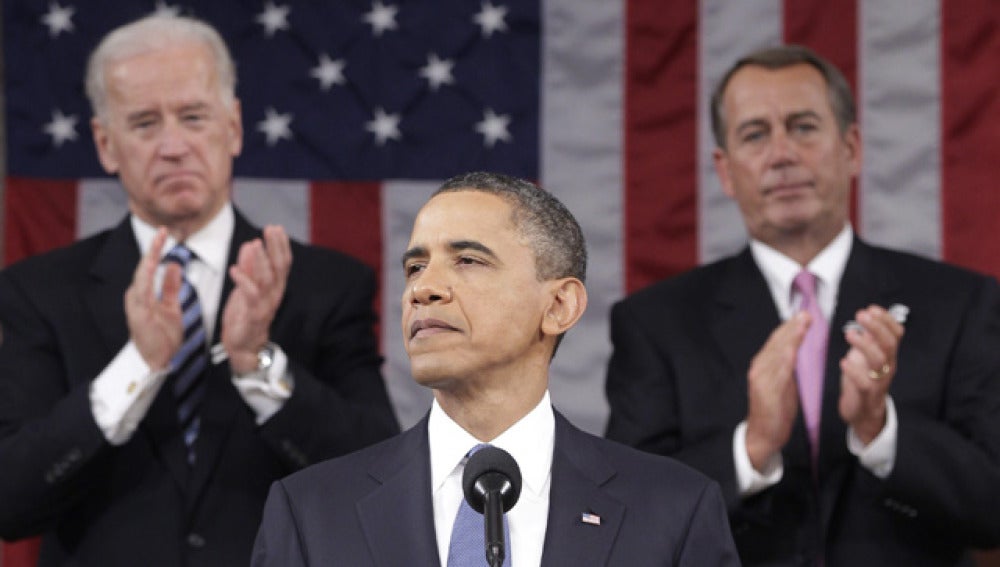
(163, 244), (208, 465)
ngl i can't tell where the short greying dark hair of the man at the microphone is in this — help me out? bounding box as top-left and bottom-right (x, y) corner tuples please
(434, 172), (587, 281)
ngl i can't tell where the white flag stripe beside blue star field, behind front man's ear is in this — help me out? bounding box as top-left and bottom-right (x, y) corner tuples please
(540, 0), (625, 434)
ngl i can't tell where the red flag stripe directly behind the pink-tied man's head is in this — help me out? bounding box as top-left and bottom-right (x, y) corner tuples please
(784, 0), (860, 226)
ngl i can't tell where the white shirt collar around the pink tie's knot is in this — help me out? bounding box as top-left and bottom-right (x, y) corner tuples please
(750, 223), (854, 302)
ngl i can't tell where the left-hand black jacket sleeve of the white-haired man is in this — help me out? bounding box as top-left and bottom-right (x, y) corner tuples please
(0, 272), (109, 539)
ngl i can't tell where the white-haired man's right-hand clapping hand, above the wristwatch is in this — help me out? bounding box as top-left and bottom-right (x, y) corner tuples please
(222, 225), (292, 374)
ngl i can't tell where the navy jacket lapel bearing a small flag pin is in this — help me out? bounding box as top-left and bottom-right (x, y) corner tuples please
(542, 412), (625, 565)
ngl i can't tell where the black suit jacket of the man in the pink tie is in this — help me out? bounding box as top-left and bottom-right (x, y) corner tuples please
(607, 239), (1000, 567)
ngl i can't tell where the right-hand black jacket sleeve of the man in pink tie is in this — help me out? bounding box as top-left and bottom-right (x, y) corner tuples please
(885, 279), (1000, 547)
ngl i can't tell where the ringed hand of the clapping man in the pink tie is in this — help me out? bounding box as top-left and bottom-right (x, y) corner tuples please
(838, 305), (903, 445)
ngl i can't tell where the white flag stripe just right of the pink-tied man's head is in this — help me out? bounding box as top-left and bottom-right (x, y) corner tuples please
(858, 0), (941, 258)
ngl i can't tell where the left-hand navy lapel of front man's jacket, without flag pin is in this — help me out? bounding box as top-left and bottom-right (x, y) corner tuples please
(357, 417), (441, 565)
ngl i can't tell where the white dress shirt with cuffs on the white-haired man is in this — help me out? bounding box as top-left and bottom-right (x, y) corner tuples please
(90, 205), (292, 445)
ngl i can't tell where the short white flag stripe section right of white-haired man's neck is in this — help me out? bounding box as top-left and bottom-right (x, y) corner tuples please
(233, 178), (312, 242)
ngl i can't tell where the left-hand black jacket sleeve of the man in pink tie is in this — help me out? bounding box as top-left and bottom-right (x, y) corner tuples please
(605, 301), (741, 508)
